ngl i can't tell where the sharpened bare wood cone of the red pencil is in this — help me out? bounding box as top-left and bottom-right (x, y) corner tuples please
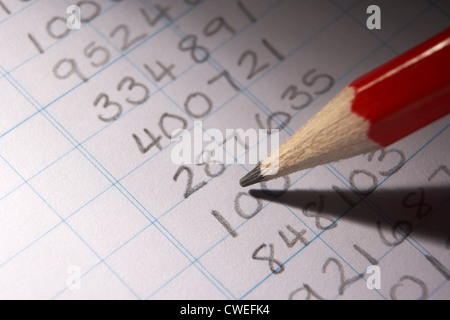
(241, 87), (381, 186)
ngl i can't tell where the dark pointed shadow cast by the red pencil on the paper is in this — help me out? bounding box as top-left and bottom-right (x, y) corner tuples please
(249, 185), (450, 242)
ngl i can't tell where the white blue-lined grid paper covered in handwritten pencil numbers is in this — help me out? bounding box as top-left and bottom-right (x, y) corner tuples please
(0, 0), (450, 300)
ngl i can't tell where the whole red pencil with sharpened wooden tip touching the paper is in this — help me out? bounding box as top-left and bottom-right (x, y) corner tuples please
(240, 28), (450, 187)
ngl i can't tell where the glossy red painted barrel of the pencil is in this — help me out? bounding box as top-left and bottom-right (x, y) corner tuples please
(350, 28), (450, 147)
